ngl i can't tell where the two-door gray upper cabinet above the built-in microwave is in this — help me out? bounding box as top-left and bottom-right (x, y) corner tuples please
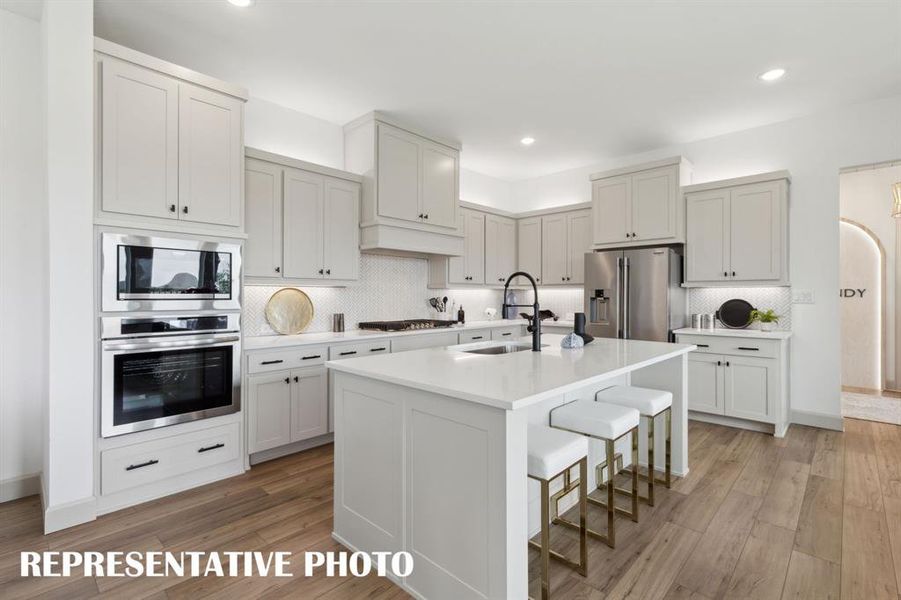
(95, 40), (246, 235)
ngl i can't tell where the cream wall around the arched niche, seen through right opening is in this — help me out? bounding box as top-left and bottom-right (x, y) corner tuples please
(839, 164), (901, 389)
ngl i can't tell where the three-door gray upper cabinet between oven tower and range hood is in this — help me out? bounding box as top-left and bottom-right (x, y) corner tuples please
(244, 148), (360, 285)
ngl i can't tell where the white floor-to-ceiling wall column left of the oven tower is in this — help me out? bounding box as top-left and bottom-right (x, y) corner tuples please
(41, 0), (95, 532)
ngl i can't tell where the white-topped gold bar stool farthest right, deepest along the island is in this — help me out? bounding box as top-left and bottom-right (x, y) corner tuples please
(594, 385), (673, 506)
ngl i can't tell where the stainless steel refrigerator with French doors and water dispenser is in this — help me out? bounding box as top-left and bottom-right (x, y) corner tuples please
(585, 246), (688, 342)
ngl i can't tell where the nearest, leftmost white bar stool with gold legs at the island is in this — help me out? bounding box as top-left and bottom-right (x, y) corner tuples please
(528, 425), (588, 600)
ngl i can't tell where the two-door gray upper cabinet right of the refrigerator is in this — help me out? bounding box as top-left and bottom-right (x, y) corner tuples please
(685, 171), (790, 286)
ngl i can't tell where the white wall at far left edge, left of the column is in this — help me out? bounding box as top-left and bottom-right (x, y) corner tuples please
(0, 9), (47, 502)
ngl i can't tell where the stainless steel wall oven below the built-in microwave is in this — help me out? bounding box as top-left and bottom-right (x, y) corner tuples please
(100, 314), (241, 437)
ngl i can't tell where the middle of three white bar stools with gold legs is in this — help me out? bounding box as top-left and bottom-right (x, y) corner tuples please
(551, 400), (640, 548)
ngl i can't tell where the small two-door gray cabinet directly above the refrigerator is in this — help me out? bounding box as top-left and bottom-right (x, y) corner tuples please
(590, 157), (691, 248)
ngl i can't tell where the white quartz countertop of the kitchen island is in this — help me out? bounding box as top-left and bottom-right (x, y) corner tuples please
(326, 334), (696, 410)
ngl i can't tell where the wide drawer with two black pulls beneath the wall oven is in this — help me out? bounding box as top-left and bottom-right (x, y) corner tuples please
(100, 423), (239, 494)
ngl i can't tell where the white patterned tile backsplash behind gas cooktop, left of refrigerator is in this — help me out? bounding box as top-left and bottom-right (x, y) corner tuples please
(243, 254), (582, 337)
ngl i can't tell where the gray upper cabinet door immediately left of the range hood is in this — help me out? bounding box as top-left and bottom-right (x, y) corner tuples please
(323, 179), (360, 279)
